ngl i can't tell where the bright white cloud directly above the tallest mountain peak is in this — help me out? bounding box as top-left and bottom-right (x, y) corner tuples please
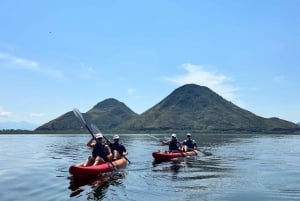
(166, 63), (239, 102)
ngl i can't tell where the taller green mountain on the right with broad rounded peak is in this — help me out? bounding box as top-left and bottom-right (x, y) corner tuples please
(120, 84), (300, 132)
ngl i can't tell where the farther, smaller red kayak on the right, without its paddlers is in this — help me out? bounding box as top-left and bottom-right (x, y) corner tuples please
(152, 150), (197, 162)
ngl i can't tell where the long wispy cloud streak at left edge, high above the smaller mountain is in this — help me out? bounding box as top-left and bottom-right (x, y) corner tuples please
(0, 52), (64, 78)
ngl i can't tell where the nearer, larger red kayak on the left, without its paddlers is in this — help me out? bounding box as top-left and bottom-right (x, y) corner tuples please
(69, 157), (127, 180)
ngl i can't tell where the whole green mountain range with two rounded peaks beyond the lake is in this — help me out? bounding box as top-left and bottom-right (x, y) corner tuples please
(36, 84), (300, 133)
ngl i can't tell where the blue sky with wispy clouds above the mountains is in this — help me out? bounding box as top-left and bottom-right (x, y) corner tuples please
(0, 0), (300, 128)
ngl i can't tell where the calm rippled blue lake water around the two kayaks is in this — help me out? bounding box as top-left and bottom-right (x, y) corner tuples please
(0, 134), (300, 201)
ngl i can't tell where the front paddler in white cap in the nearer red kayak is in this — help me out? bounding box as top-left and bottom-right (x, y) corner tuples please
(84, 133), (112, 166)
